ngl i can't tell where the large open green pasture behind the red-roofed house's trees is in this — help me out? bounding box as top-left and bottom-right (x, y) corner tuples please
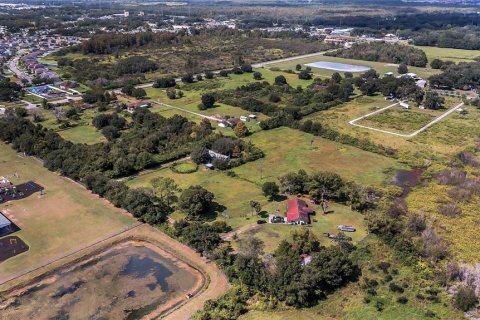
(233, 128), (402, 185)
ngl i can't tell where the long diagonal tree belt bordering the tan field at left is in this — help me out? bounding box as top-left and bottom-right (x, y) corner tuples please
(0, 116), (171, 224)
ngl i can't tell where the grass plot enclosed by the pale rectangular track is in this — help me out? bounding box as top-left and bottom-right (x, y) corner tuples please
(356, 105), (435, 134)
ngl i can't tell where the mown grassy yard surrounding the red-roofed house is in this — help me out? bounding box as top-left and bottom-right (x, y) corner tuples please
(232, 201), (366, 254)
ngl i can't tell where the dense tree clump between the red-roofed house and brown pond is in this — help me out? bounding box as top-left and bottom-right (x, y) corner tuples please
(188, 226), (360, 319)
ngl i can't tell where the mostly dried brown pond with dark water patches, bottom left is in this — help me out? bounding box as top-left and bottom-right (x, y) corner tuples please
(0, 244), (199, 319)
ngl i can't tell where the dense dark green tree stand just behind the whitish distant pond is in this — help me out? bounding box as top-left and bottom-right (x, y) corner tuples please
(325, 42), (428, 67)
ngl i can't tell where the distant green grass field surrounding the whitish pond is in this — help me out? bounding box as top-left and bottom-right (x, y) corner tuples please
(267, 54), (440, 78)
